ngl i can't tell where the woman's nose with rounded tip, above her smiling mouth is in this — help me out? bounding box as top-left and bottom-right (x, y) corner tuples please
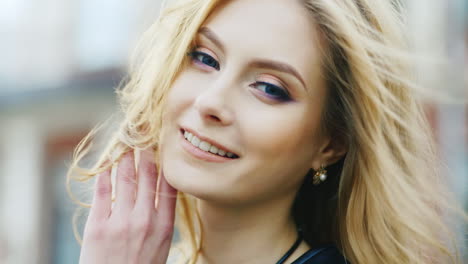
(194, 80), (234, 126)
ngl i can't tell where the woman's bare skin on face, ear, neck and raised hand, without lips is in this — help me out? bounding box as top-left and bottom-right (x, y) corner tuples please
(80, 0), (345, 264)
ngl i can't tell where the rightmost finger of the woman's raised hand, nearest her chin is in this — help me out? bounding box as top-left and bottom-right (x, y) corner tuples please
(156, 171), (177, 225)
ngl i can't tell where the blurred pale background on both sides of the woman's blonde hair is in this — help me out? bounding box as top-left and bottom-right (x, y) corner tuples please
(0, 0), (468, 264)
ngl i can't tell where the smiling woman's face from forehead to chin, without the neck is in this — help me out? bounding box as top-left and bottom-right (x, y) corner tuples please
(161, 0), (332, 204)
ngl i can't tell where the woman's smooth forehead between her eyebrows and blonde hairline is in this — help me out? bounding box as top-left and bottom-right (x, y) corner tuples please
(199, 0), (319, 86)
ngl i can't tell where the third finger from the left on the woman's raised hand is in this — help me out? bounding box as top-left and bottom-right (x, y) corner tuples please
(135, 149), (158, 210)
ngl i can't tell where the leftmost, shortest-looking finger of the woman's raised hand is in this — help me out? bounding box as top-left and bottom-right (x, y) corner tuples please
(89, 168), (112, 220)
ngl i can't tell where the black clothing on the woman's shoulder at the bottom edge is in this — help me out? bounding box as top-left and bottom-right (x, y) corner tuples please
(292, 244), (351, 264)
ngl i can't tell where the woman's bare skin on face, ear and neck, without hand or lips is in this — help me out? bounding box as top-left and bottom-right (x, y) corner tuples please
(162, 0), (344, 263)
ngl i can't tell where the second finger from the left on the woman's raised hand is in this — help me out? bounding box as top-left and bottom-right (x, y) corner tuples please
(115, 151), (137, 212)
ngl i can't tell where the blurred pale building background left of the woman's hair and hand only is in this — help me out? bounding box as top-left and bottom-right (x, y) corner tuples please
(0, 0), (160, 264)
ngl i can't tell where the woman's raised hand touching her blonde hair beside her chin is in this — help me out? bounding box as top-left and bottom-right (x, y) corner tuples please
(80, 150), (177, 264)
